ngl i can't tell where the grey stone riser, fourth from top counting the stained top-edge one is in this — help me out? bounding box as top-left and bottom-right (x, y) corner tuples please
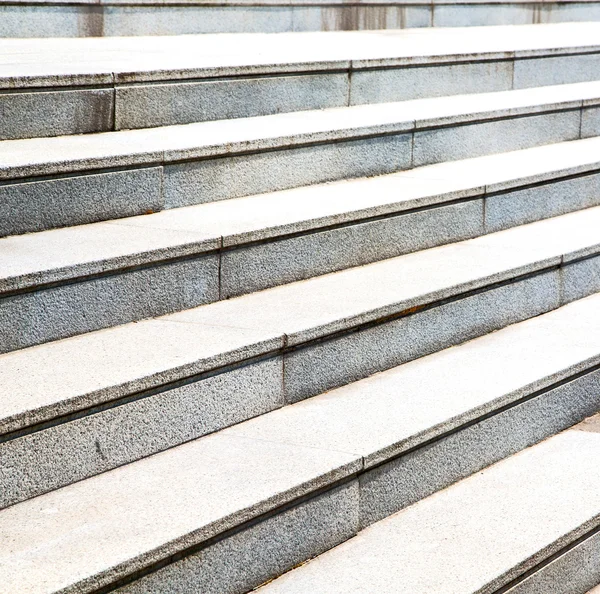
(0, 166), (600, 352)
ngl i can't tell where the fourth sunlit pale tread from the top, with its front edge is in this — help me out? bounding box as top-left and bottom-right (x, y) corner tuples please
(0, 207), (600, 431)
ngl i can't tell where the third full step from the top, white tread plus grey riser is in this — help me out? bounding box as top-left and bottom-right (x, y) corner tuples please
(0, 137), (600, 352)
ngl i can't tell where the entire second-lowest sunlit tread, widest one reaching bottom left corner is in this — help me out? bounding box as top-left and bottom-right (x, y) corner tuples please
(0, 296), (600, 593)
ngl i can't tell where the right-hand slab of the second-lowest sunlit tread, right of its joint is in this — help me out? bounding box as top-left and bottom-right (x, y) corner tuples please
(222, 294), (600, 468)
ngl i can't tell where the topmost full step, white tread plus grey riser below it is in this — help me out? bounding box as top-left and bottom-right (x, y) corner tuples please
(0, 22), (600, 139)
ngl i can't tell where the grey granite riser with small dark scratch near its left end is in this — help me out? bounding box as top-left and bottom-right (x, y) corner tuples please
(0, 257), (600, 507)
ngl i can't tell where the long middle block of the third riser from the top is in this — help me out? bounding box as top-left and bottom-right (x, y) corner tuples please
(164, 134), (411, 208)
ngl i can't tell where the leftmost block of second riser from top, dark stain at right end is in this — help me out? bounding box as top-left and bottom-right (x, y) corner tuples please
(0, 88), (113, 140)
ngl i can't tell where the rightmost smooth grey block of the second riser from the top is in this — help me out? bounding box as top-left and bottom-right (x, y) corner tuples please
(513, 54), (600, 89)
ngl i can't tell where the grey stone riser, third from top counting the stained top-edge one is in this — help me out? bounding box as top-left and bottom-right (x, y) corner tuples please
(0, 100), (600, 236)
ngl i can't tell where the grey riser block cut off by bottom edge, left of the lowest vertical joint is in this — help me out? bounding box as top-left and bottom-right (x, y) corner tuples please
(117, 481), (358, 594)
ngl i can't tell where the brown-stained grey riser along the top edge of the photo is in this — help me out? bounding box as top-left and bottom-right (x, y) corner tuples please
(0, 0), (600, 37)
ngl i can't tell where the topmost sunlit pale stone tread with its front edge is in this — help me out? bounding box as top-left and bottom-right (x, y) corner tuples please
(0, 23), (600, 89)
